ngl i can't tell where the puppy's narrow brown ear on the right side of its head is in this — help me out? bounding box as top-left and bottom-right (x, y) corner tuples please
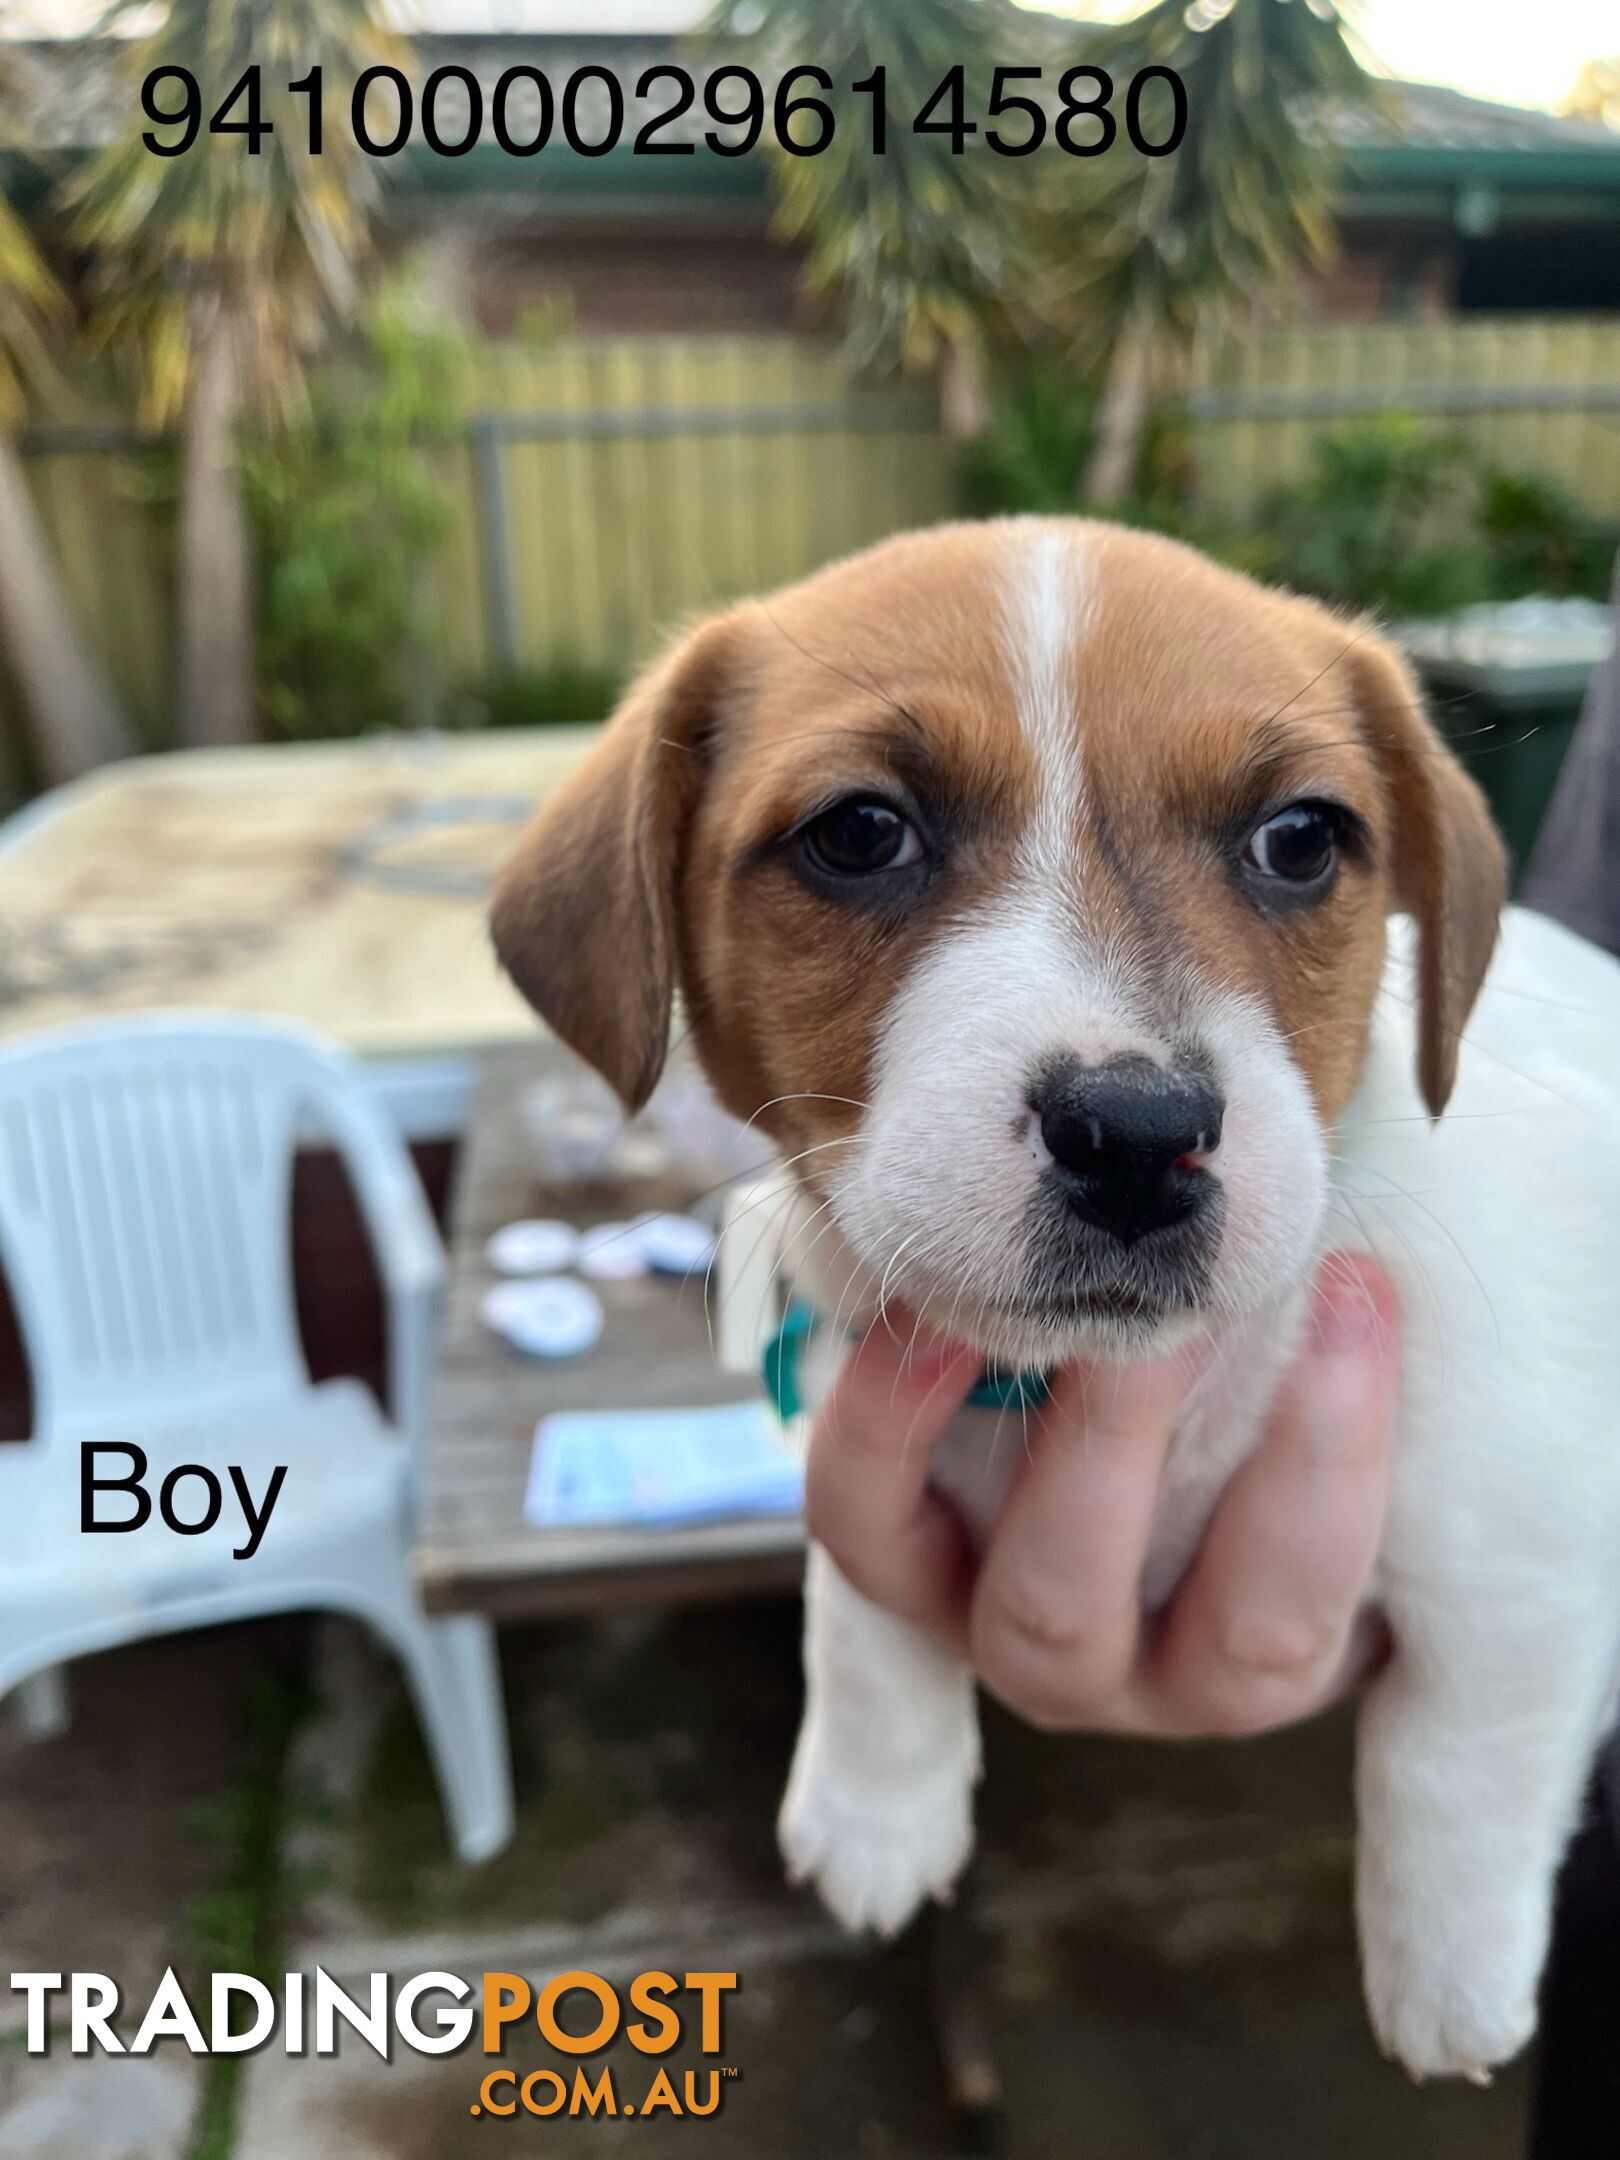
(1346, 633), (1508, 1117)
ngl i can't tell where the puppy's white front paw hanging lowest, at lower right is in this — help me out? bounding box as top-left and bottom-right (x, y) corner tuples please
(1361, 1907), (1544, 2084)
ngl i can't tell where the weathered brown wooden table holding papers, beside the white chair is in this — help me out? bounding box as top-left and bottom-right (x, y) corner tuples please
(417, 1039), (804, 1618)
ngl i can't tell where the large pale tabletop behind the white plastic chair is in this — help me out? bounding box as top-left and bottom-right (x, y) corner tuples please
(0, 728), (598, 1136)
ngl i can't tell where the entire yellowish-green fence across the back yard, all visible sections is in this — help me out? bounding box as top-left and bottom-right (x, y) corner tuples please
(0, 318), (1620, 784)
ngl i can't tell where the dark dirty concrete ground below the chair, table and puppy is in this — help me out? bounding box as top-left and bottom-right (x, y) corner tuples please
(0, 1605), (1523, 2160)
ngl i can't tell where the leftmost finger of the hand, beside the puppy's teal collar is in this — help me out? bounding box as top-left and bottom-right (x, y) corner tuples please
(804, 1309), (978, 1639)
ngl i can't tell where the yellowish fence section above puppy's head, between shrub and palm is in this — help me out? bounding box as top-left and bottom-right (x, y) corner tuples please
(445, 337), (950, 672)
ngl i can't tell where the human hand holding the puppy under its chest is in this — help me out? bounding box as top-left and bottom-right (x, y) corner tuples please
(806, 1253), (1398, 1737)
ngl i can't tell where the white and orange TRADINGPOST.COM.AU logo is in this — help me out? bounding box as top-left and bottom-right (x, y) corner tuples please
(11, 1968), (739, 2121)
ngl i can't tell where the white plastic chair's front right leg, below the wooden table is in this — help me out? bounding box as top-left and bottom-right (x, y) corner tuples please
(397, 1614), (512, 1864)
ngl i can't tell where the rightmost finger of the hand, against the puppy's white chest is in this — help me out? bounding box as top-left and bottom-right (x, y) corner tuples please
(1143, 1255), (1398, 1732)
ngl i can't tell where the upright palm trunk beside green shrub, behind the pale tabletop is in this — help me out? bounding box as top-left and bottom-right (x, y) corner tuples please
(179, 307), (257, 743)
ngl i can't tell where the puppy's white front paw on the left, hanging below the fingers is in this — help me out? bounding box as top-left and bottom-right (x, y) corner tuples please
(775, 1739), (974, 1935)
